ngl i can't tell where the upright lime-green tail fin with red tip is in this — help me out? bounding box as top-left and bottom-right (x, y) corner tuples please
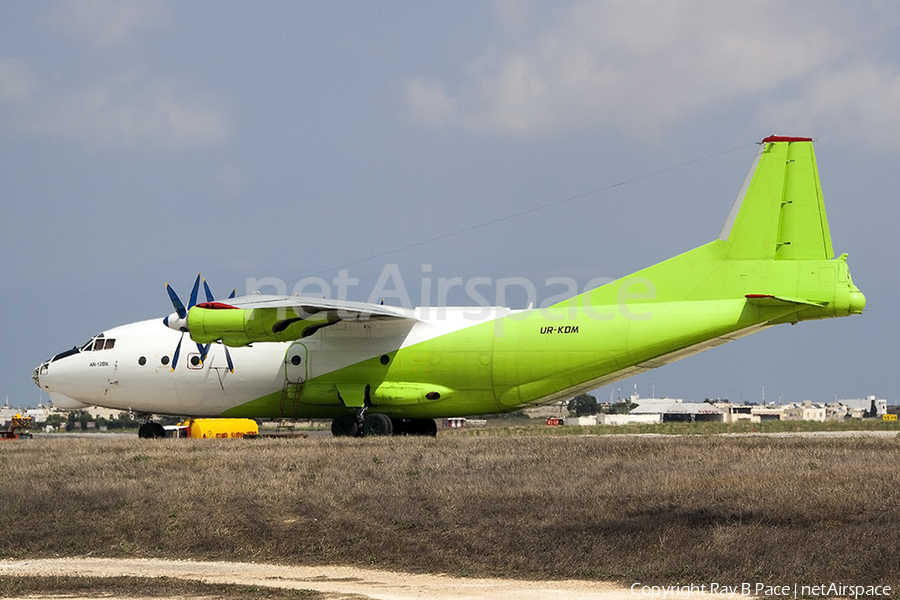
(719, 136), (834, 260)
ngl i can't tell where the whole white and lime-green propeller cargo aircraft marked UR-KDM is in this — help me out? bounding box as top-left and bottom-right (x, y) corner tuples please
(33, 136), (866, 437)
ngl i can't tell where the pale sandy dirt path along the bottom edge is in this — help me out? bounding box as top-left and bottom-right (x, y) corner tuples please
(0, 558), (732, 600)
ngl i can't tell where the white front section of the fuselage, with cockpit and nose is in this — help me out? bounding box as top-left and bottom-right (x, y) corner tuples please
(33, 308), (511, 417)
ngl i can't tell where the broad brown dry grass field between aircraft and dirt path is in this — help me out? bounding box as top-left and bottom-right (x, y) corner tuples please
(0, 434), (900, 590)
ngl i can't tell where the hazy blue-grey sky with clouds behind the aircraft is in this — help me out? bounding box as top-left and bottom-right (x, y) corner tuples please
(0, 0), (900, 405)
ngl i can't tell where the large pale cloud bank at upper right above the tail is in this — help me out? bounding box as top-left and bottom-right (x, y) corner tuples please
(406, 0), (900, 145)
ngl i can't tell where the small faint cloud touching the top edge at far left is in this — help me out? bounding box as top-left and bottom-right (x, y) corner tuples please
(46, 0), (170, 49)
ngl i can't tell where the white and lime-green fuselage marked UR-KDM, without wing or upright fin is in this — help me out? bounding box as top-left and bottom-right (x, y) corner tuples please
(34, 262), (865, 418)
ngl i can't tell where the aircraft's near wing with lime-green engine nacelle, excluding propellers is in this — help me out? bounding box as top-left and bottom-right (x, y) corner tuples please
(188, 294), (416, 346)
